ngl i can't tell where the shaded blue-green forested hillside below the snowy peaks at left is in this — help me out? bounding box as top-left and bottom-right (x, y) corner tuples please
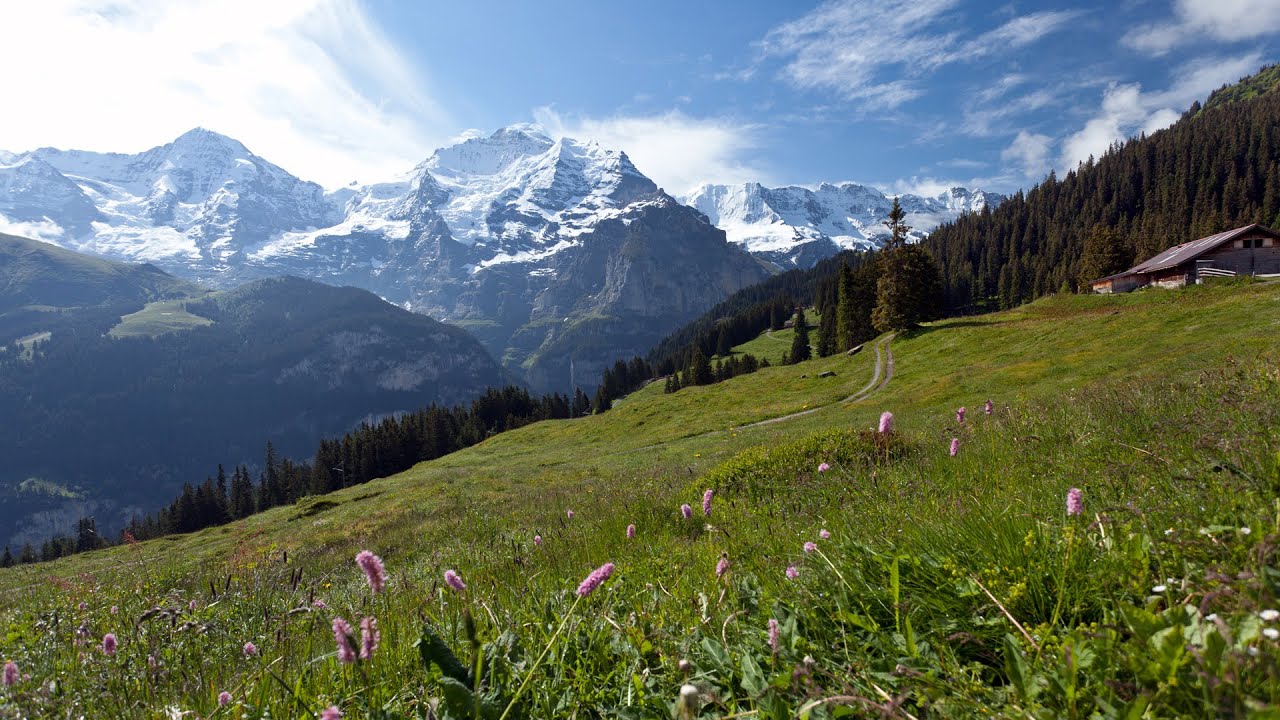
(0, 267), (508, 546)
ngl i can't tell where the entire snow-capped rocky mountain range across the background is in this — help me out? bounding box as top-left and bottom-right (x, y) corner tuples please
(0, 126), (1000, 391)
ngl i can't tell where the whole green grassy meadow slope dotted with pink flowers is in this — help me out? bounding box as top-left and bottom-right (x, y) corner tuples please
(0, 284), (1280, 717)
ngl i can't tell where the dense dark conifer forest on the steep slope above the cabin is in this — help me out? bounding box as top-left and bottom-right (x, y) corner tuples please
(924, 65), (1280, 313)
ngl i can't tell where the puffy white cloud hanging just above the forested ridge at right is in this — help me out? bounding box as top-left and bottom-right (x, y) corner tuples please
(1059, 53), (1262, 169)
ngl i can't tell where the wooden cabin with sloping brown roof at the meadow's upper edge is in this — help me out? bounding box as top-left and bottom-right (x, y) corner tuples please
(1089, 224), (1280, 293)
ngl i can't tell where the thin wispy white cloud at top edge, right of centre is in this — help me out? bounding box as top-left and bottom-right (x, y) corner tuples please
(760, 0), (1079, 109)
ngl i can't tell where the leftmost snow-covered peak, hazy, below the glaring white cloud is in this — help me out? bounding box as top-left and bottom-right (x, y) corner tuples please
(0, 128), (342, 269)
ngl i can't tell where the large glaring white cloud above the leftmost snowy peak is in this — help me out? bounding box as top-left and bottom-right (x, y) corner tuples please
(0, 0), (454, 186)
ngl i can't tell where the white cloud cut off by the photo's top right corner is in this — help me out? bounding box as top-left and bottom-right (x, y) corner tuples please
(1124, 0), (1280, 56)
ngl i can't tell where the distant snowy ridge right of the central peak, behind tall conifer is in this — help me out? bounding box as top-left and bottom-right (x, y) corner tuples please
(682, 183), (1004, 268)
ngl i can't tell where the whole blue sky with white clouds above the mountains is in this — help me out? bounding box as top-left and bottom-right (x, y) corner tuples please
(0, 0), (1280, 195)
